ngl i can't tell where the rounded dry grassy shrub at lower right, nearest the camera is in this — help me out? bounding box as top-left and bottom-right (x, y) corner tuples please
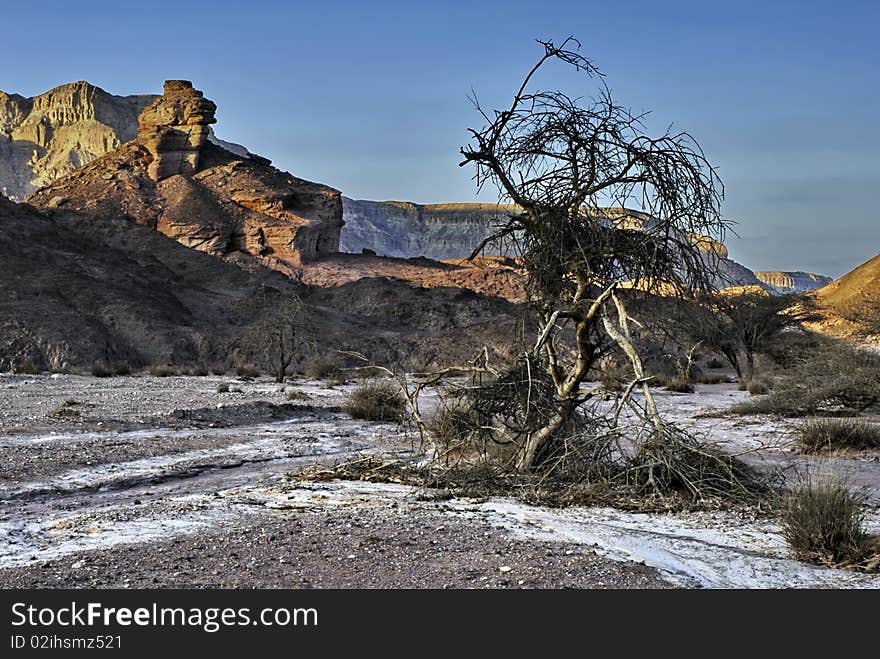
(782, 477), (867, 565)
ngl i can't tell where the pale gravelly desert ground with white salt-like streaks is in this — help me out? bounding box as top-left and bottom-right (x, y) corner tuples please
(0, 375), (880, 588)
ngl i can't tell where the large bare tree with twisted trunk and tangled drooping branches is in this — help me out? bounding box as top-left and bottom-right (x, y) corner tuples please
(461, 37), (725, 470)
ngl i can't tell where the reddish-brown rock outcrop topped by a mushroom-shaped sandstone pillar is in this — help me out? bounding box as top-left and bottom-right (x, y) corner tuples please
(28, 81), (342, 274)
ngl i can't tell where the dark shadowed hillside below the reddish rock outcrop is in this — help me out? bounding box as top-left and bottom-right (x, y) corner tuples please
(0, 193), (517, 371)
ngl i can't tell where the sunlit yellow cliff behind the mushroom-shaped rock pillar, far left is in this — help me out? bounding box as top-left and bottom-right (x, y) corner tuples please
(0, 81), (156, 199)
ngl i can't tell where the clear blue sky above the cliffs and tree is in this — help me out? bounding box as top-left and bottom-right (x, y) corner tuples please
(0, 0), (880, 276)
